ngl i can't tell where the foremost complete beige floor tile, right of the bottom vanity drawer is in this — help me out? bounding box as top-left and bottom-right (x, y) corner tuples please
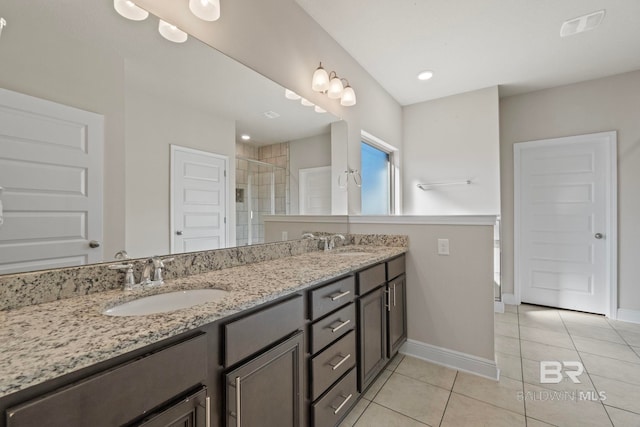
(373, 373), (450, 426)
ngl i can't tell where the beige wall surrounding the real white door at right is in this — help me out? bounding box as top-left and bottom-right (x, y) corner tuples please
(500, 71), (640, 310)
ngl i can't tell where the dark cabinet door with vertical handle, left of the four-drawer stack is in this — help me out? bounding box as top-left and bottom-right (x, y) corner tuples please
(225, 332), (304, 427)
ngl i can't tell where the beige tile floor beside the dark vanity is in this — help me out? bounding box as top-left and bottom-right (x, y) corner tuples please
(341, 305), (640, 427)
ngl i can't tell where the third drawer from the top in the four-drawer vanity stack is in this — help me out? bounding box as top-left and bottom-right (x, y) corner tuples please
(311, 331), (356, 400)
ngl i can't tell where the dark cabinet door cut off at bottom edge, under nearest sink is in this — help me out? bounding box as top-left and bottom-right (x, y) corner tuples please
(136, 389), (211, 427)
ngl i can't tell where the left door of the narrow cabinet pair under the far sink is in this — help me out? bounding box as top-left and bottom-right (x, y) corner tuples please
(358, 286), (388, 392)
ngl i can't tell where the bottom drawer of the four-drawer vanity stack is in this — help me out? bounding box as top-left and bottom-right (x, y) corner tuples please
(312, 369), (358, 427)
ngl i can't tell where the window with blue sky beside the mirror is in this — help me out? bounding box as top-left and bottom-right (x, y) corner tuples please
(360, 141), (391, 215)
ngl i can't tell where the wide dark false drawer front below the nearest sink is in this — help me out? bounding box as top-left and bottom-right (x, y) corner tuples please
(7, 335), (207, 427)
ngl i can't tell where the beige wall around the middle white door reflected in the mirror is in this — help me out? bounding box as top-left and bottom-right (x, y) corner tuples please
(124, 83), (236, 258)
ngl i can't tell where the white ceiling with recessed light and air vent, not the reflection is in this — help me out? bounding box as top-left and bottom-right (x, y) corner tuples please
(296, 0), (640, 105)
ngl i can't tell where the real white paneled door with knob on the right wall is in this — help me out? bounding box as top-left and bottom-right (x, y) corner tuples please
(514, 132), (616, 315)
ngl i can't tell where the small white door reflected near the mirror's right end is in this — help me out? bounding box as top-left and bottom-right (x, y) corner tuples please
(298, 166), (331, 215)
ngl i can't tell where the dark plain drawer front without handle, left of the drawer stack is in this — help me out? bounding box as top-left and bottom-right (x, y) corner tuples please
(224, 295), (304, 367)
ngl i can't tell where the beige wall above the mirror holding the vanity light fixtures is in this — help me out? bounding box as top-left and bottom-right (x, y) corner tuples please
(136, 0), (402, 214)
